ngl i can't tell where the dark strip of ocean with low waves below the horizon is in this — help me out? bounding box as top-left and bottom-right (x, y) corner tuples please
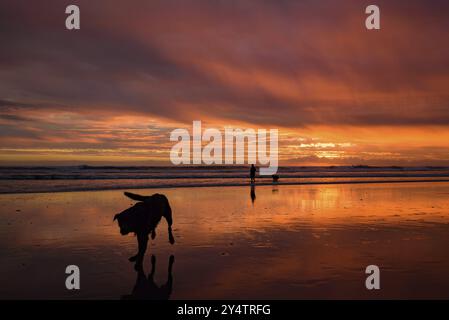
(0, 165), (449, 194)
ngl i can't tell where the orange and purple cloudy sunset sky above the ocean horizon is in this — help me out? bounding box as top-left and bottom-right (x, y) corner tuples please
(0, 0), (449, 165)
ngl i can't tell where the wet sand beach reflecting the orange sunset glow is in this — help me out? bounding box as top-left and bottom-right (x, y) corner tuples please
(0, 182), (449, 299)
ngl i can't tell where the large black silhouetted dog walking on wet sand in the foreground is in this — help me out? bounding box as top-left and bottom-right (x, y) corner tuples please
(114, 192), (175, 269)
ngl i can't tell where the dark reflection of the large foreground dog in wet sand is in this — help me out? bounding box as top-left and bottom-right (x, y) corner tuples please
(122, 255), (175, 300)
